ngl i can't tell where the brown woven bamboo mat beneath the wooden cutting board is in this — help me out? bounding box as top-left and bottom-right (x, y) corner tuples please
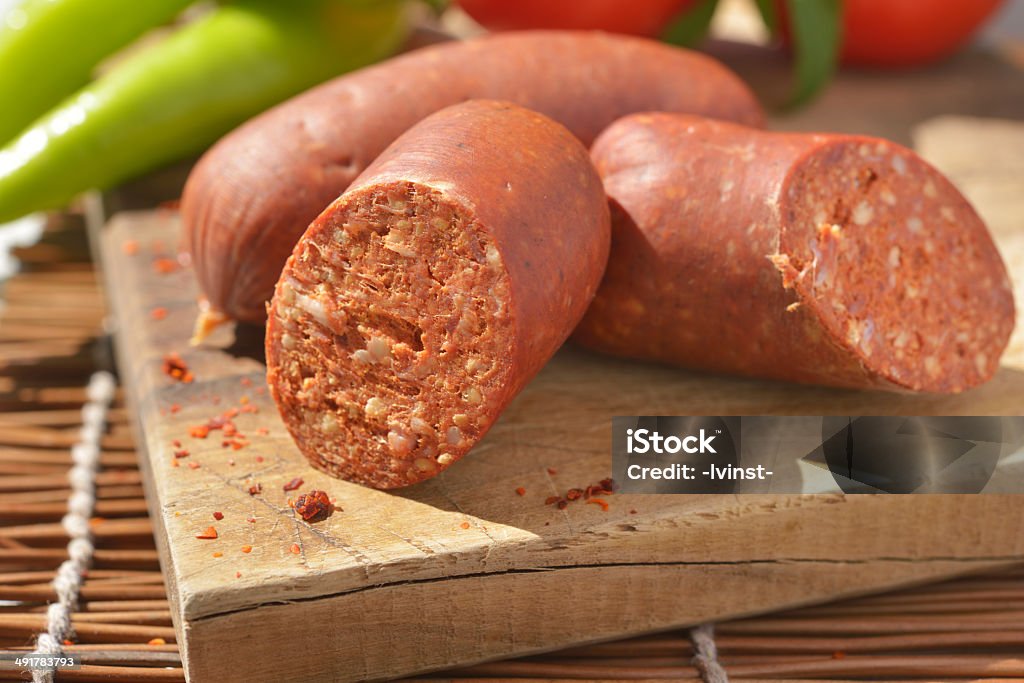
(0, 211), (1024, 681)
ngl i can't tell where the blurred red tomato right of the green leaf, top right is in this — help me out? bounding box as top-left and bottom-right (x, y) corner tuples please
(841, 0), (1002, 67)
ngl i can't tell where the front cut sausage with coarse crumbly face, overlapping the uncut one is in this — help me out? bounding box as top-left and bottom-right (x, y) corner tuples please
(266, 100), (610, 488)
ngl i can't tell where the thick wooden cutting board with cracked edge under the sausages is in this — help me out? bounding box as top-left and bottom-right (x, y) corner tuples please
(101, 126), (1024, 681)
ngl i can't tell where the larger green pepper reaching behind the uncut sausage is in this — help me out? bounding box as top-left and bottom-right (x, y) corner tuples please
(0, 0), (407, 222)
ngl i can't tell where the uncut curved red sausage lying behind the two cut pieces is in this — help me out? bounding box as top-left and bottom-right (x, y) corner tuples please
(181, 32), (764, 331)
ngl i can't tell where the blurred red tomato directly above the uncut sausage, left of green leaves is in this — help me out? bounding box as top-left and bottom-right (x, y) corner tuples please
(458, 0), (696, 36)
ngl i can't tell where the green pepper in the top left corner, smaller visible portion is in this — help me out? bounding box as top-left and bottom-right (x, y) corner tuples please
(0, 0), (193, 143)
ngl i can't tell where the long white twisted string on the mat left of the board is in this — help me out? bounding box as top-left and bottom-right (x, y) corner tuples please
(32, 371), (116, 683)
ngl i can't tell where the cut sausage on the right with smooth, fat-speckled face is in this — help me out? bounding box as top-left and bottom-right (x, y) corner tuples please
(574, 114), (1015, 393)
